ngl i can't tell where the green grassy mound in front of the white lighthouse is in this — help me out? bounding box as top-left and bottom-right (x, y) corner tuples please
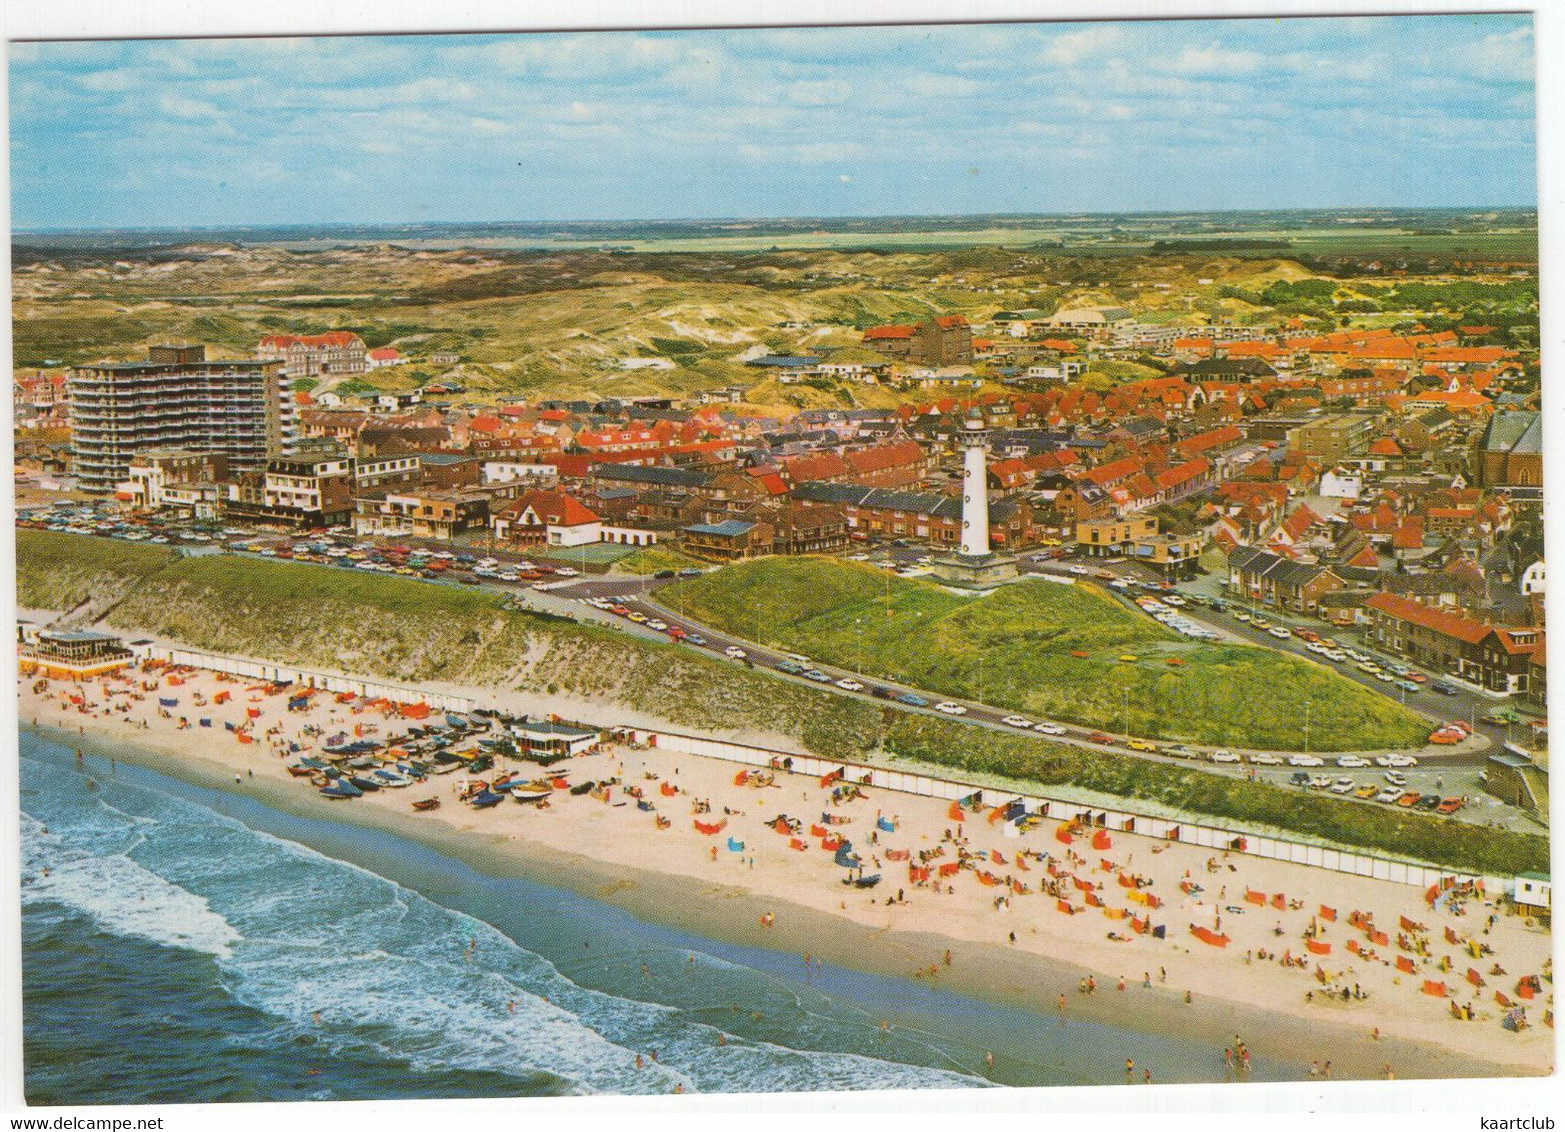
(662, 557), (1429, 750)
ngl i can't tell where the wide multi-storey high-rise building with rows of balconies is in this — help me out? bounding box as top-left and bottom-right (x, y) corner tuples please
(66, 346), (293, 492)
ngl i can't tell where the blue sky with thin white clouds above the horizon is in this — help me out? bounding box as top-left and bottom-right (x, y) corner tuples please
(9, 14), (1537, 229)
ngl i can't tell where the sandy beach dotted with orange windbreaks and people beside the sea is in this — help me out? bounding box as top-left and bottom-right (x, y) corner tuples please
(20, 670), (1554, 1079)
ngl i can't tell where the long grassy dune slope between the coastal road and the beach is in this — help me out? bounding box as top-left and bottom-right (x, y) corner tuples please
(17, 531), (1548, 875)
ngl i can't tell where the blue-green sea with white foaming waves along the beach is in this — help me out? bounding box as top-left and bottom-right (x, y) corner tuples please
(20, 731), (1299, 1105)
